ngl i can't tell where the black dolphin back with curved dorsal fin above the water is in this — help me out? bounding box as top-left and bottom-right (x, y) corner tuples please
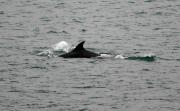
(59, 41), (99, 58)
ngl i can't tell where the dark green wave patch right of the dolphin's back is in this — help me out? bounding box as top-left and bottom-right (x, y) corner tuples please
(126, 56), (156, 62)
